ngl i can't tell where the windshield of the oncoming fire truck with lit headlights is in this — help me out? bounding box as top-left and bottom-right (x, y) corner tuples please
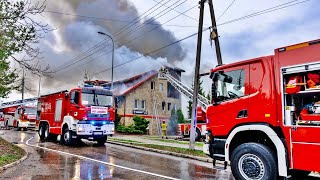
(82, 93), (113, 107)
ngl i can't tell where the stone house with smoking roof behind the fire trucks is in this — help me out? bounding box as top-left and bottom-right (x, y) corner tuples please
(108, 68), (184, 134)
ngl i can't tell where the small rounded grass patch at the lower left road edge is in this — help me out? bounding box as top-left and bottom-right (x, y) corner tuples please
(0, 138), (25, 166)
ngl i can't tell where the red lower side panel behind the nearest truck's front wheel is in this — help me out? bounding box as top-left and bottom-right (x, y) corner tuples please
(290, 125), (320, 172)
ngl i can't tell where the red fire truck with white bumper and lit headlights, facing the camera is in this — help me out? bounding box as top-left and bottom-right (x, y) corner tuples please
(37, 86), (115, 145)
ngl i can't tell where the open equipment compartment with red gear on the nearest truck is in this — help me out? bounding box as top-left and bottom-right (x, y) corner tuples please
(283, 67), (320, 126)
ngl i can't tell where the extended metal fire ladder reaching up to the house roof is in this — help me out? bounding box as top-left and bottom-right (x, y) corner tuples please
(158, 68), (210, 111)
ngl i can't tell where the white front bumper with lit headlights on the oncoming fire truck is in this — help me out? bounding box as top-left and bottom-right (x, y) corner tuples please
(77, 123), (114, 137)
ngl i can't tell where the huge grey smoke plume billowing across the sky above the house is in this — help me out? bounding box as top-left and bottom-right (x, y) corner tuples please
(21, 0), (186, 94)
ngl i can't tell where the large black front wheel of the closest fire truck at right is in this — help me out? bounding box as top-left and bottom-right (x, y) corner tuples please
(231, 143), (278, 180)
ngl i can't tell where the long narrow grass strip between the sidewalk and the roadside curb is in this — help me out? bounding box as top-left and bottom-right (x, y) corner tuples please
(110, 138), (208, 157)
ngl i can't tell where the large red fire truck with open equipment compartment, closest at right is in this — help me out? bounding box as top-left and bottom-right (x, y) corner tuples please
(204, 40), (320, 180)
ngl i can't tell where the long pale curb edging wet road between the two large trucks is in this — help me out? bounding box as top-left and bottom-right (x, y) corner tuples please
(107, 141), (214, 164)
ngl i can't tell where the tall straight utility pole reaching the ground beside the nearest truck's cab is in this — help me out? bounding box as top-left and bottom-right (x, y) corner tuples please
(189, 0), (206, 150)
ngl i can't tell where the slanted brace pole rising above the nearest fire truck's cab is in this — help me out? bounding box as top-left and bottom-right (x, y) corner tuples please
(208, 0), (222, 65)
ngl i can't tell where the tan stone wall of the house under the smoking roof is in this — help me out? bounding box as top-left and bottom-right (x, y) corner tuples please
(118, 75), (181, 135)
